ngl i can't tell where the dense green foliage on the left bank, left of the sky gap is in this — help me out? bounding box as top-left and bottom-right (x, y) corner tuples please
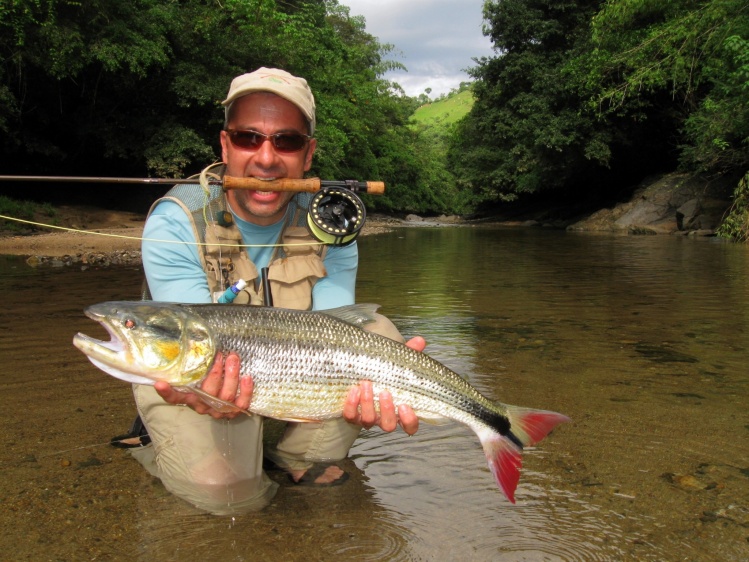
(0, 0), (438, 211)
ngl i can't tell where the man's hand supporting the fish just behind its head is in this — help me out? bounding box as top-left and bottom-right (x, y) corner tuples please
(154, 353), (253, 419)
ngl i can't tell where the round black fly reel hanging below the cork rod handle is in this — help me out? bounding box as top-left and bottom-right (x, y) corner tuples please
(307, 187), (367, 246)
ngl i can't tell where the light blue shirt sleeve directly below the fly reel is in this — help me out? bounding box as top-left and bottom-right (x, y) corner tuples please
(312, 242), (359, 310)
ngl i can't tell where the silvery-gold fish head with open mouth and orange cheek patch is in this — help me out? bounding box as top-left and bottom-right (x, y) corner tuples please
(73, 301), (217, 386)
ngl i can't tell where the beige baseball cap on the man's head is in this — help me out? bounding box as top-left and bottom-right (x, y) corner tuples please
(221, 67), (316, 134)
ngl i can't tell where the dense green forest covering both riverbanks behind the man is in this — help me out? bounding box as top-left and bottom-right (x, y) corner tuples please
(0, 0), (749, 230)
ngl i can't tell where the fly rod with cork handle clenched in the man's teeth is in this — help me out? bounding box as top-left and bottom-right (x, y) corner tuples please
(0, 176), (385, 195)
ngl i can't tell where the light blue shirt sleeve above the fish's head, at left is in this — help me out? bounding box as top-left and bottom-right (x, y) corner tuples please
(141, 201), (211, 303)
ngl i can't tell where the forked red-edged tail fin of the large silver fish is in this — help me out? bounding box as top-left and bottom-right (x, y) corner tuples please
(479, 406), (569, 503)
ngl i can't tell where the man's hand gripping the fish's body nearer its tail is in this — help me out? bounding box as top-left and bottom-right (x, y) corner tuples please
(343, 336), (426, 435)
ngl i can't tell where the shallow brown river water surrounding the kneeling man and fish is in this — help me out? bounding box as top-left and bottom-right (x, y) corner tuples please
(0, 227), (749, 561)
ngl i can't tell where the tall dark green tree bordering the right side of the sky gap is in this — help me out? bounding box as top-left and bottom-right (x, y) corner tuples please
(450, 0), (610, 201)
